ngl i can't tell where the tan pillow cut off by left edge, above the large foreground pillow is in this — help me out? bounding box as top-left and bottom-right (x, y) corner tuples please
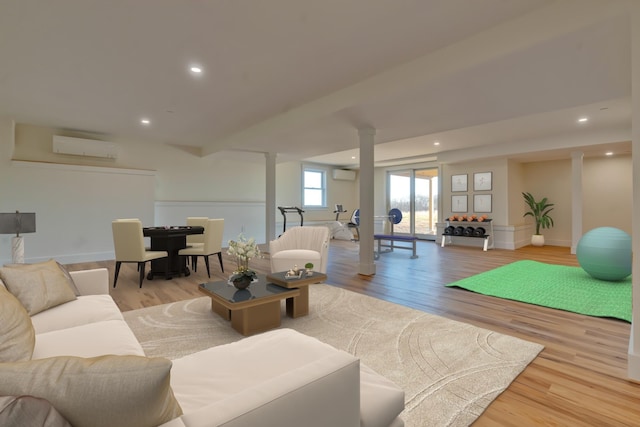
(0, 286), (36, 362)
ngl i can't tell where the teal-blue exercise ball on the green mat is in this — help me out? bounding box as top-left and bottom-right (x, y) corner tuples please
(576, 227), (631, 281)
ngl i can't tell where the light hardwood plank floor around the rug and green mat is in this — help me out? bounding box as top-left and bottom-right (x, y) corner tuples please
(68, 241), (640, 427)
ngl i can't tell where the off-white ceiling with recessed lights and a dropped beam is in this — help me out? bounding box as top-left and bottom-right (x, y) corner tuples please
(0, 0), (631, 167)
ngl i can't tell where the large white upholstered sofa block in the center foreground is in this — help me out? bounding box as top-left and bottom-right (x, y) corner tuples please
(171, 329), (360, 427)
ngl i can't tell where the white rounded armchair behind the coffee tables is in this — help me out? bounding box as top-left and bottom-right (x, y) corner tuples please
(269, 226), (329, 273)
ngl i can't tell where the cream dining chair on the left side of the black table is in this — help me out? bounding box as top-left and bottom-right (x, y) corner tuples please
(111, 219), (169, 288)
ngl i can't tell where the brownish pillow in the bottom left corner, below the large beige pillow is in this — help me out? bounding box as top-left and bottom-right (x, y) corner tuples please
(0, 396), (71, 427)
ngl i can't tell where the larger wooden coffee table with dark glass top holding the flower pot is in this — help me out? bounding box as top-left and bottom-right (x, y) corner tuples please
(198, 275), (300, 336)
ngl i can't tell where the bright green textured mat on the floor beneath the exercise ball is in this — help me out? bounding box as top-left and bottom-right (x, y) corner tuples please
(446, 260), (632, 322)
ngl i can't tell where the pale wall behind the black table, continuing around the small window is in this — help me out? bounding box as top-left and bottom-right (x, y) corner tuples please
(0, 118), (357, 263)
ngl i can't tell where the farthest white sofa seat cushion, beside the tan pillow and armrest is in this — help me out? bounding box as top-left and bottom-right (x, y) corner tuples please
(31, 295), (123, 334)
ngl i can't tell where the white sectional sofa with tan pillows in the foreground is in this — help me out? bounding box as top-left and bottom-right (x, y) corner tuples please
(0, 269), (404, 427)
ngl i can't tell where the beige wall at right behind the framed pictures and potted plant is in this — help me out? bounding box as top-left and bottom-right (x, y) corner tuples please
(441, 155), (632, 249)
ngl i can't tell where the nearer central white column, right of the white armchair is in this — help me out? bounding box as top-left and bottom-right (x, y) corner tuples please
(358, 128), (376, 276)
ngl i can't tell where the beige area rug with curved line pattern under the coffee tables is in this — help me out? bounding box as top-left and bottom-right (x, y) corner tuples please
(124, 284), (543, 427)
